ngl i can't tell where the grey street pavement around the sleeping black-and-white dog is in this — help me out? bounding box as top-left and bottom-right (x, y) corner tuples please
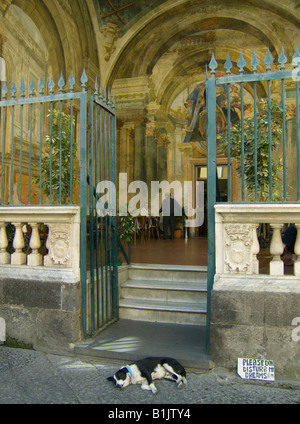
(0, 347), (300, 408)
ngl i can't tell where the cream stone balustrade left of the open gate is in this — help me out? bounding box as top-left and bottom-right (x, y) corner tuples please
(0, 206), (80, 281)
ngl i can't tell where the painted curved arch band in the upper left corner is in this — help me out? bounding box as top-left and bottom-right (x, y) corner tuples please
(4, 0), (99, 83)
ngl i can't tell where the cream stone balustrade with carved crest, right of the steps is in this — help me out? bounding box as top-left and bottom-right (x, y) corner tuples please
(215, 203), (300, 276)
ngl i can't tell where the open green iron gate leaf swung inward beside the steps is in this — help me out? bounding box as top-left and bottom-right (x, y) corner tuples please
(82, 83), (118, 335)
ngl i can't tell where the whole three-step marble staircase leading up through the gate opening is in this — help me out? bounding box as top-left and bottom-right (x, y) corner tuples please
(119, 264), (207, 325)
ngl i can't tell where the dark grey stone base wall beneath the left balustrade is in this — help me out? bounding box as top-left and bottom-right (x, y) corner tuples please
(0, 278), (81, 351)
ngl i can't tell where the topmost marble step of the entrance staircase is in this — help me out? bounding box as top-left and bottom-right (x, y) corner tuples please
(129, 264), (207, 283)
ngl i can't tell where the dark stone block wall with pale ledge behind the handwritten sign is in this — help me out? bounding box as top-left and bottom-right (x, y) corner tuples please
(211, 275), (300, 377)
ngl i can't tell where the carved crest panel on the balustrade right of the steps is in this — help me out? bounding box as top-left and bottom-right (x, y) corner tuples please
(224, 224), (259, 274)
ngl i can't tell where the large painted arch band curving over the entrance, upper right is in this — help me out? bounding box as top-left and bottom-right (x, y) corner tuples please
(109, 0), (300, 85)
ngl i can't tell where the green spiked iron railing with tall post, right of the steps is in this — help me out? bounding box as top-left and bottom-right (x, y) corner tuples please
(206, 48), (300, 350)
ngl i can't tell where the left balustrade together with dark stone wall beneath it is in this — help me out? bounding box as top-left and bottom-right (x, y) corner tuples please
(0, 206), (81, 351)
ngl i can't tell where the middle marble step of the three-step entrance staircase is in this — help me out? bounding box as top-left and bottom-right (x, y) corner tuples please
(120, 280), (207, 303)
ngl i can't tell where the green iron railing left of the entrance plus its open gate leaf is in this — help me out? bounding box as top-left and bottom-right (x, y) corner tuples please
(0, 71), (122, 338)
